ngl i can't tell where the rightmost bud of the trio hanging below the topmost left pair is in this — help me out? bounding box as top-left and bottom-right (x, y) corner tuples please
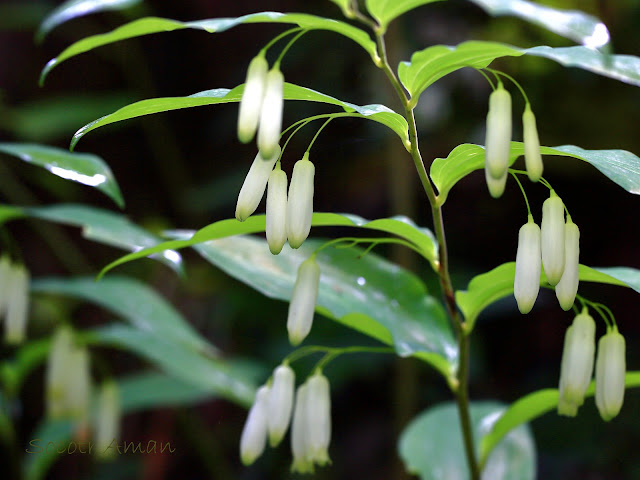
(287, 153), (315, 248)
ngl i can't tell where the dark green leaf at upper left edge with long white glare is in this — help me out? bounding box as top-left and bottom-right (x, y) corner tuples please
(0, 143), (124, 208)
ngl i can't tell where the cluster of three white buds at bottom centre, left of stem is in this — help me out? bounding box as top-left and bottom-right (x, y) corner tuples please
(240, 364), (331, 473)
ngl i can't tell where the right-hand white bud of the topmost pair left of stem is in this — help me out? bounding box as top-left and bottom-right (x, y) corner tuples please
(258, 67), (284, 158)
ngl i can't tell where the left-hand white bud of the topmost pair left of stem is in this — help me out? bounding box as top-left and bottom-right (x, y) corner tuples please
(238, 55), (269, 143)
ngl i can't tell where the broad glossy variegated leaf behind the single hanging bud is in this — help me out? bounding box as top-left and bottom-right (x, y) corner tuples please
(190, 236), (458, 378)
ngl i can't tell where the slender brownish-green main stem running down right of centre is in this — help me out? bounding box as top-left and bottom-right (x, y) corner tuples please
(375, 30), (480, 480)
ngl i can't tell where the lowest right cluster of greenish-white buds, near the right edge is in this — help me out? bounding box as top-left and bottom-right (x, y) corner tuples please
(558, 307), (626, 421)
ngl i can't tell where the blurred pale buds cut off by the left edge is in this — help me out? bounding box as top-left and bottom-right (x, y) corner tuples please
(0, 255), (29, 344)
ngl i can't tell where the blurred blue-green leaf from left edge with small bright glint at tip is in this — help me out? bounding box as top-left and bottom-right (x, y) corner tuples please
(0, 204), (183, 273)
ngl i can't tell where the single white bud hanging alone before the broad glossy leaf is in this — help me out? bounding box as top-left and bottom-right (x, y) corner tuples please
(287, 255), (320, 345)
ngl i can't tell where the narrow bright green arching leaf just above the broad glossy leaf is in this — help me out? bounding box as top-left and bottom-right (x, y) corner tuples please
(100, 211), (438, 277)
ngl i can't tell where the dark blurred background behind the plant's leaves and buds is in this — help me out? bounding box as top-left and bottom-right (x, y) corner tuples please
(0, 0), (640, 480)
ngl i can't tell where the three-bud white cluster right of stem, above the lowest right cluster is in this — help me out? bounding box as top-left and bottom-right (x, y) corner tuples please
(513, 190), (580, 314)
